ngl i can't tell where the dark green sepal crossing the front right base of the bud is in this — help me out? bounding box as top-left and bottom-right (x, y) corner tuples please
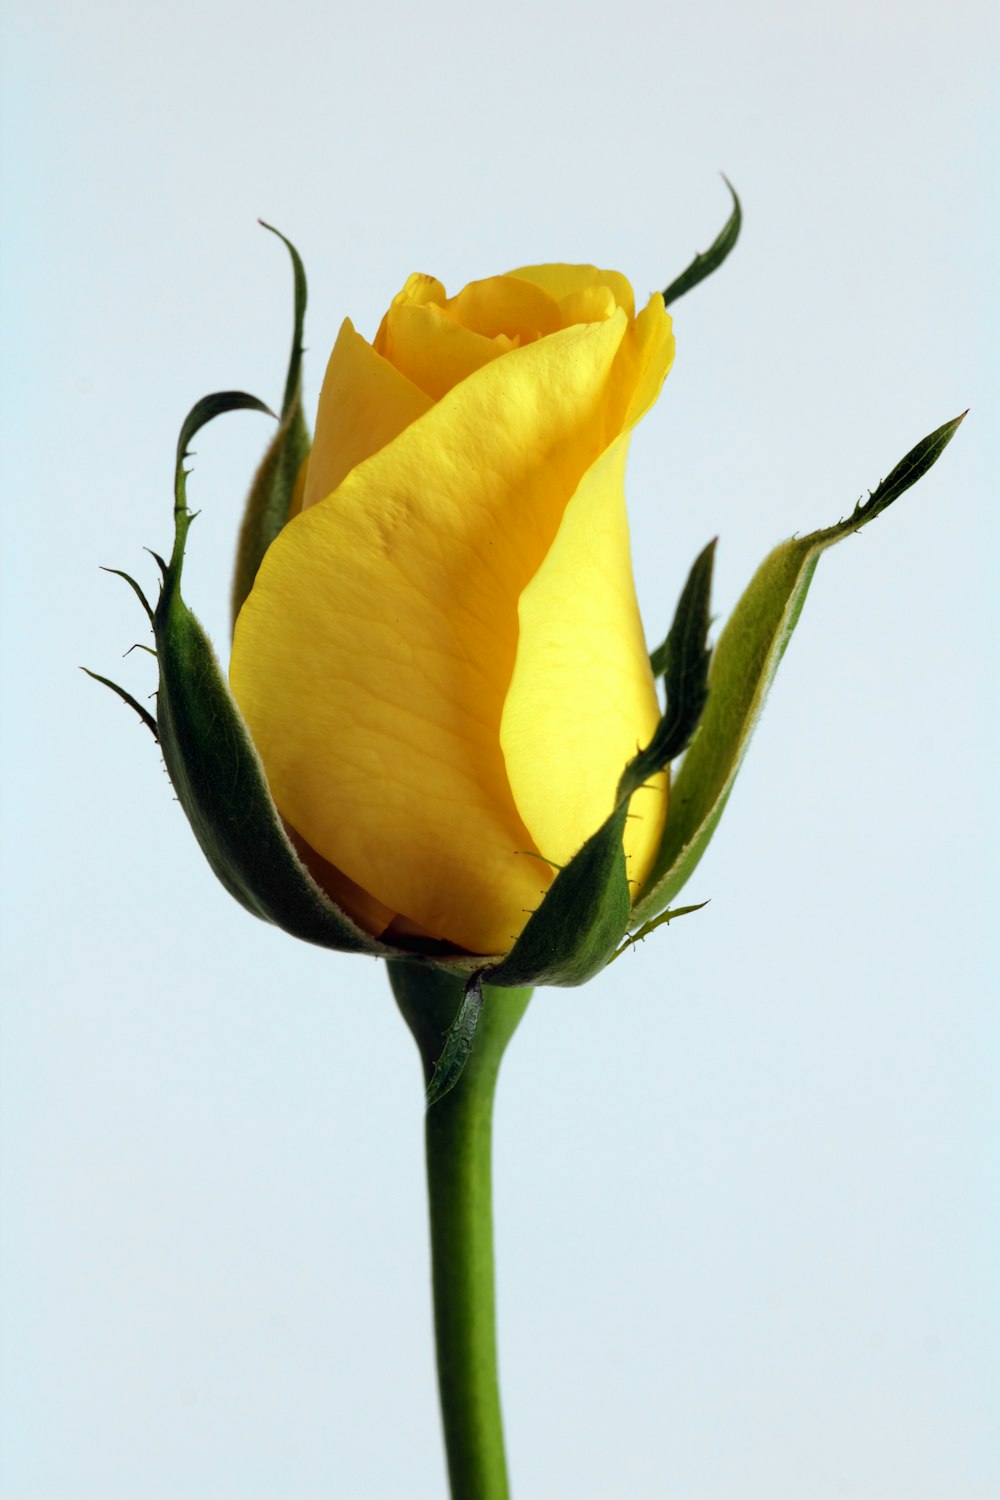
(486, 542), (715, 986)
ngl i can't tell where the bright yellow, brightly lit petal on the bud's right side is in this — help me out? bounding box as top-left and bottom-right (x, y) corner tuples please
(501, 434), (667, 894)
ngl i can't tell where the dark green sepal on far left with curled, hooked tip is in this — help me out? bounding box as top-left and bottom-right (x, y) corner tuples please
(145, 392), (399, 956)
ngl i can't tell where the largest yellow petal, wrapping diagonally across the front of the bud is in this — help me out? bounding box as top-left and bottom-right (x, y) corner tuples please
(231, 309), (627, 953)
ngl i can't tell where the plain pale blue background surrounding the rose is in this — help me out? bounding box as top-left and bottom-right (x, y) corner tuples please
(0, 0), (1000, 1500)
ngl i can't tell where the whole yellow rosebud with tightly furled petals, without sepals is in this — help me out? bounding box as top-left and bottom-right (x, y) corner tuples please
(229, 266), (673, 954)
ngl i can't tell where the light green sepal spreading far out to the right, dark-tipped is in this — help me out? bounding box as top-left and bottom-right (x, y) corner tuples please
(633, 413), (964, 930)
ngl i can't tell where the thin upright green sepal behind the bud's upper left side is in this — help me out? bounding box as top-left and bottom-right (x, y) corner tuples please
(232, 219), (312, 626)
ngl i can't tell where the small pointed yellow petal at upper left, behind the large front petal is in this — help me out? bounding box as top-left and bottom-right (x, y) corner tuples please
(301, 318), (432, 515)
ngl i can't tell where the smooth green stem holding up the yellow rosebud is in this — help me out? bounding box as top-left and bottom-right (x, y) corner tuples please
(388, 963), (531, 1500)
